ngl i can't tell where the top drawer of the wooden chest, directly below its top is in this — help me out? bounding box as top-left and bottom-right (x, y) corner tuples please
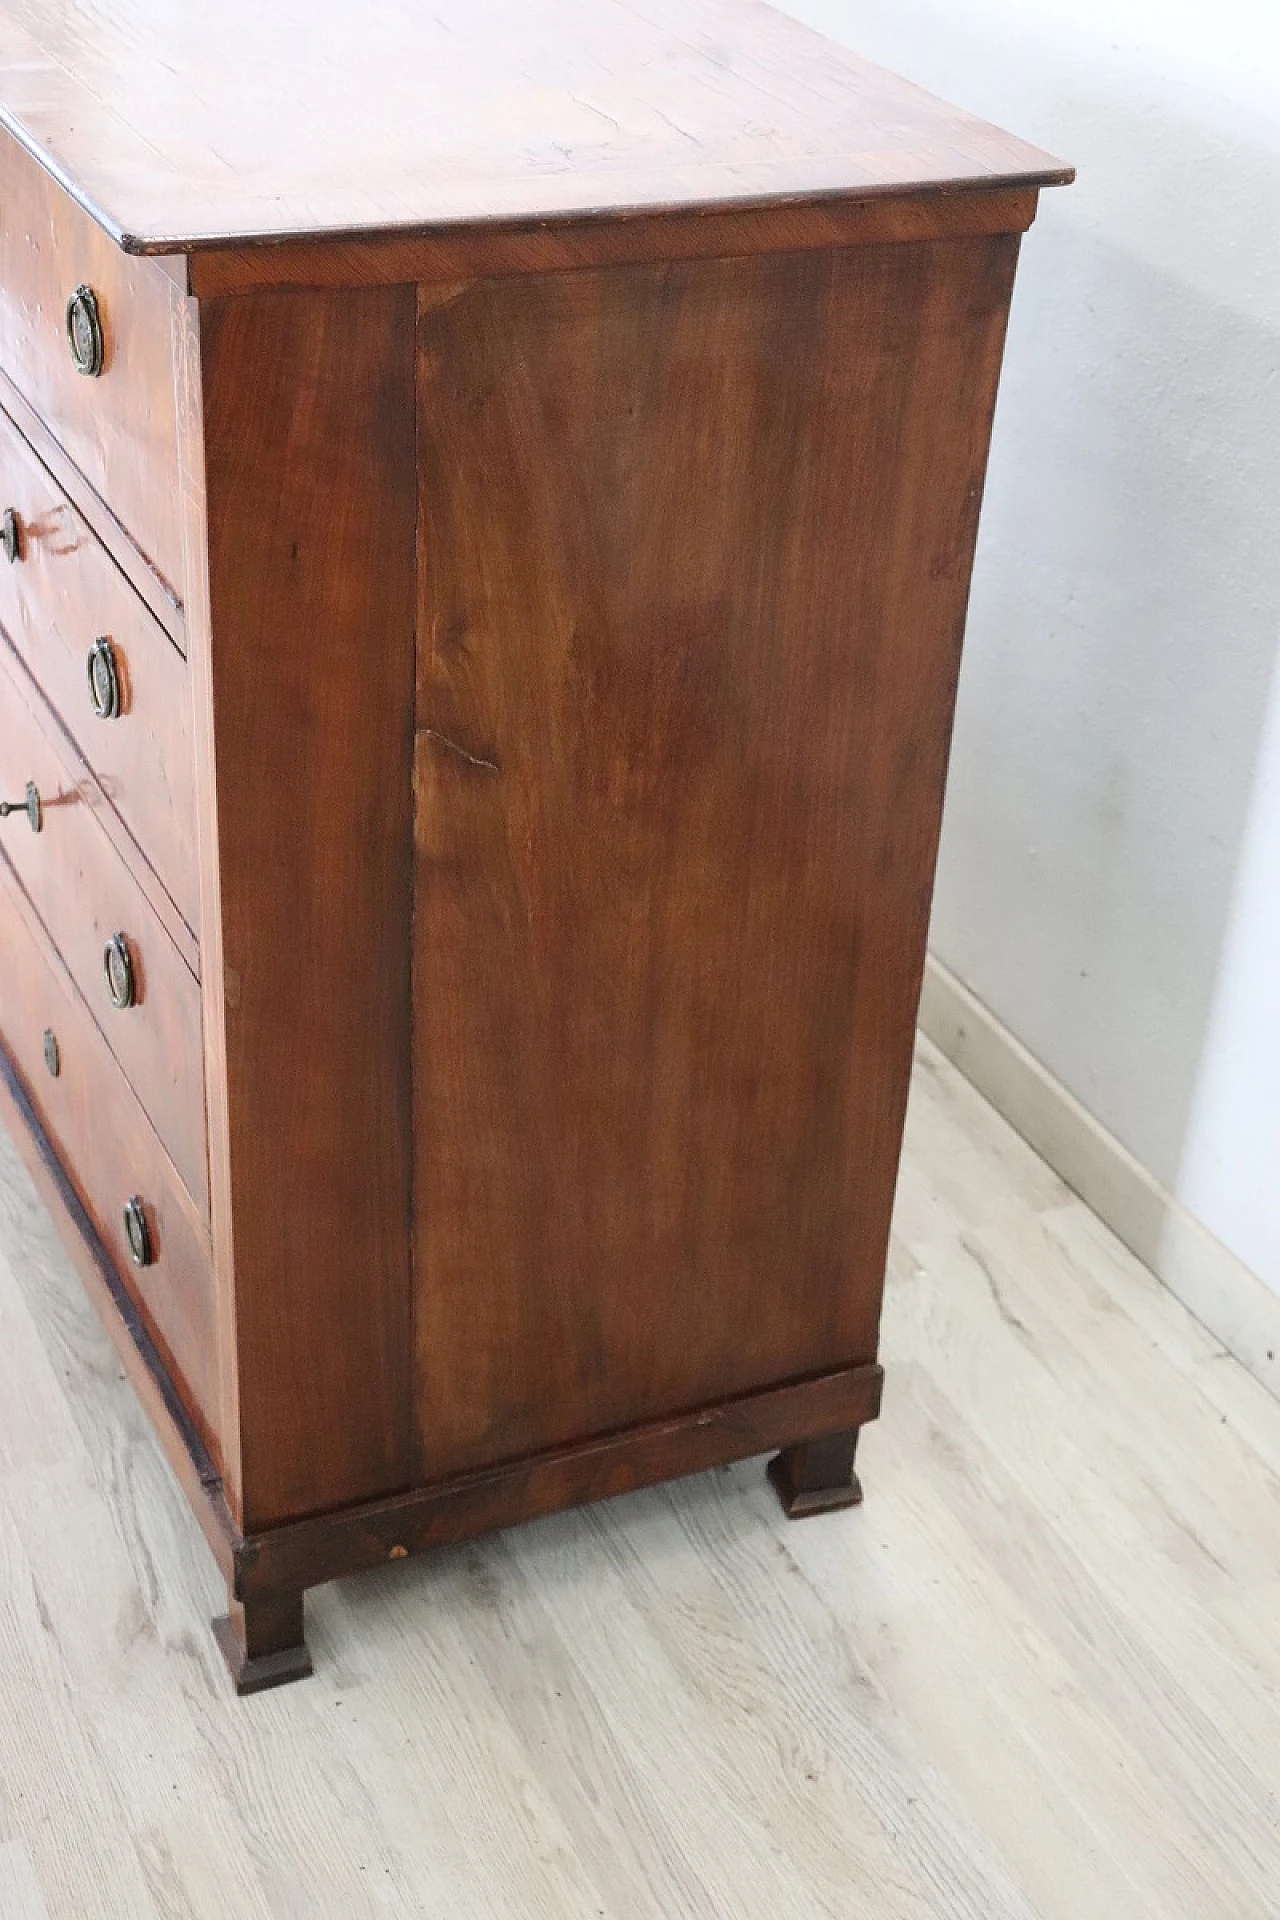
(0, 132), (182, 597)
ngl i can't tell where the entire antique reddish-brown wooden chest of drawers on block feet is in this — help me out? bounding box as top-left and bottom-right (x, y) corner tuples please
(0, 0), (1069, 1690)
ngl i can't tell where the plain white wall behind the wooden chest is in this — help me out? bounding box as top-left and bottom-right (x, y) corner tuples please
(787, 0), (1280, 1292)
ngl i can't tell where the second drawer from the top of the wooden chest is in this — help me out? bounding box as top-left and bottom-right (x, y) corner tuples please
(0, 413), (200, 927)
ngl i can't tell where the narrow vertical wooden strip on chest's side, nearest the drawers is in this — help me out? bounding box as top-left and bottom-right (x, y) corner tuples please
(188, 286), (416, 1530)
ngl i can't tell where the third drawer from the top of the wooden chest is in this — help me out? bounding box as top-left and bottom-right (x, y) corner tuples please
(0, 645), (209, 1215)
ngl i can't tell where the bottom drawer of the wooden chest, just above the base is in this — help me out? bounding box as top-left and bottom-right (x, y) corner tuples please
(0, 854), (217, 1430)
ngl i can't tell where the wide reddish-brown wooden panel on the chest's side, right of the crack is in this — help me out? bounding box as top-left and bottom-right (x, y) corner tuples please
(415, 234), (1017, 1478)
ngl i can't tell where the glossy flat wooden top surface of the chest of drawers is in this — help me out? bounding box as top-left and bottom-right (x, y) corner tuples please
(0, 0), (1069, 252)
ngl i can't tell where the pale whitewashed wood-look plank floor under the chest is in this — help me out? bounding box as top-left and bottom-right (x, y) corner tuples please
(0, 1043), (1280, 1920)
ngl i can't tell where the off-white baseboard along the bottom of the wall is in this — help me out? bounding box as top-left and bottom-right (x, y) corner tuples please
(919, 954), (1280, 1398)
